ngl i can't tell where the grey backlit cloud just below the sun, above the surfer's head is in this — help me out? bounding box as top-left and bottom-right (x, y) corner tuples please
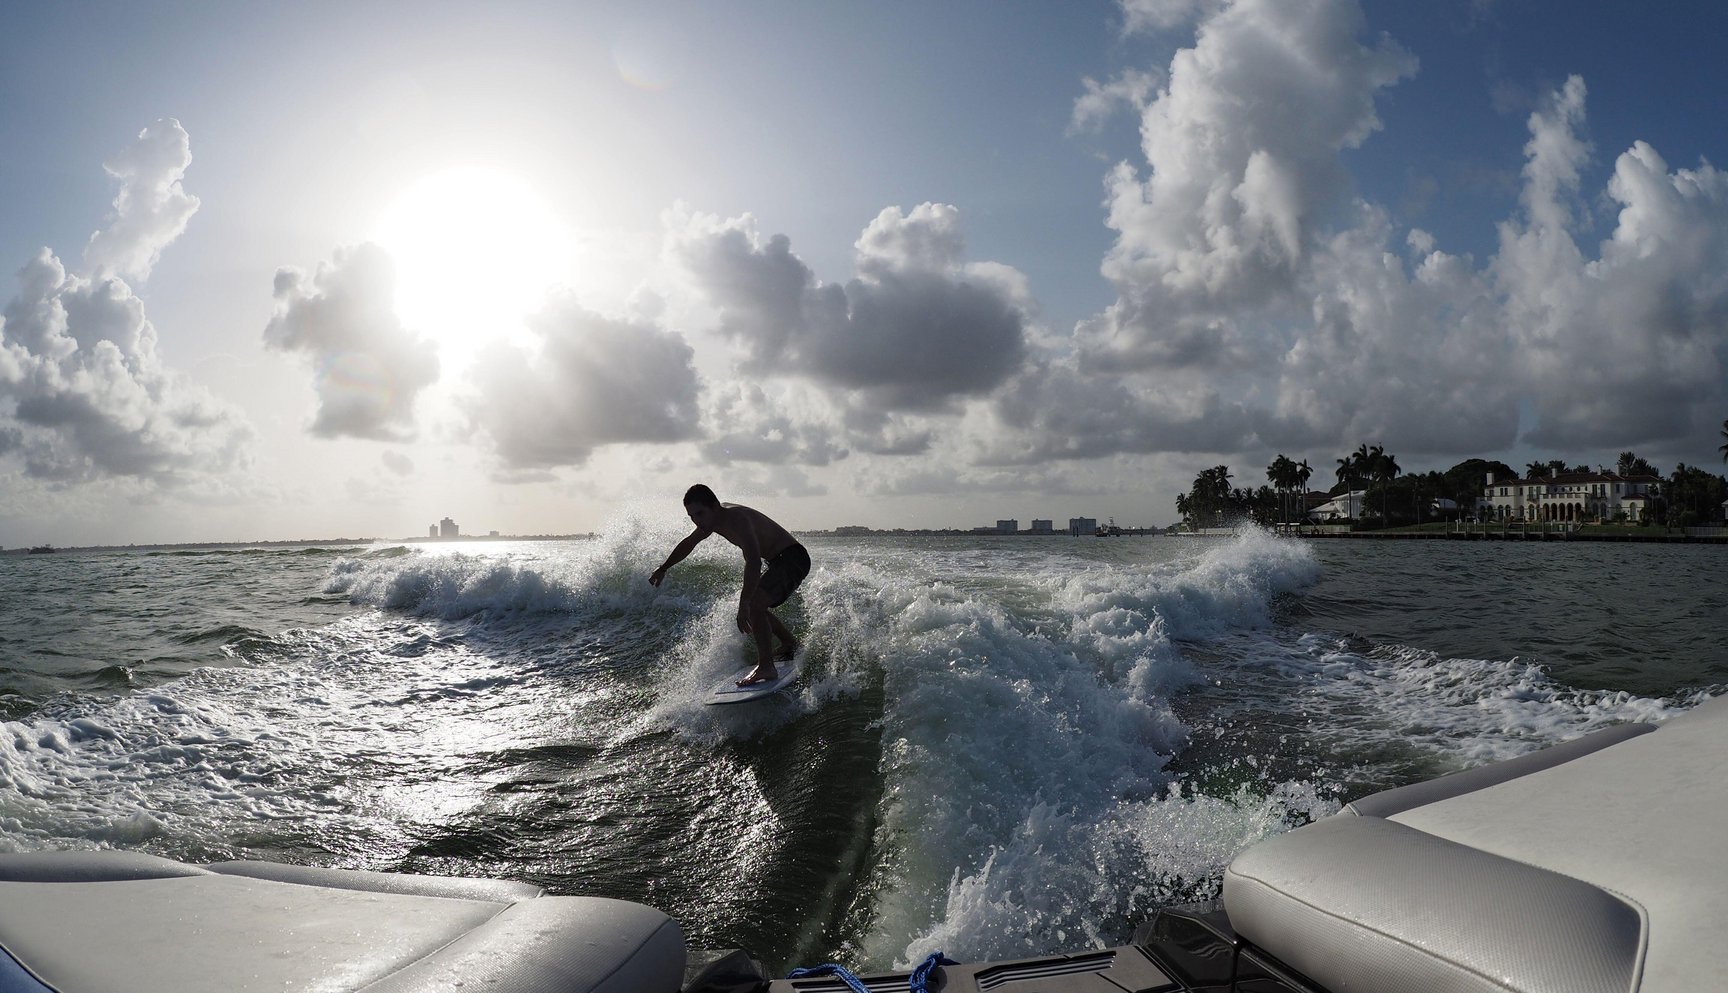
(467, 294), (700, 478)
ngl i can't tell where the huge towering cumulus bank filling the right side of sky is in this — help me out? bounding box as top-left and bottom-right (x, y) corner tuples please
(1043, 0), (1728, 461)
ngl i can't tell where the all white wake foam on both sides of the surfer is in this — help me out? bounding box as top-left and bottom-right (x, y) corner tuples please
(0, 528), (1692, 965)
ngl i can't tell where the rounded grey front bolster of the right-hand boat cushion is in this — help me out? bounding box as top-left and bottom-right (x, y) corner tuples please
(1223, 817), (1643, 993)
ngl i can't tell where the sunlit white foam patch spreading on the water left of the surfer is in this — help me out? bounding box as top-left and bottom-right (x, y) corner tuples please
(0, 615), (537, 858)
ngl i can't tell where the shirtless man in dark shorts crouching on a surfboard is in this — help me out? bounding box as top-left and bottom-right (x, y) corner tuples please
(648, 484), (810, 686)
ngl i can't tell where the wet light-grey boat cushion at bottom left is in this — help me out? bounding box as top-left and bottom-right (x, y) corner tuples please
(0, 853), (684, 993)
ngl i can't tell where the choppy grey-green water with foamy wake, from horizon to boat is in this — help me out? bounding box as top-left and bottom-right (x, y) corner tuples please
(0, 528), (1728, 969)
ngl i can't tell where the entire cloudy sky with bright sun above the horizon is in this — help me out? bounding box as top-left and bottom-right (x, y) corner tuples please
(0, 0), (1728, 547)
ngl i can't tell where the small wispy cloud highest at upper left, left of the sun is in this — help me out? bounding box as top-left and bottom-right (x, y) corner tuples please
(85, 117), (199, 281)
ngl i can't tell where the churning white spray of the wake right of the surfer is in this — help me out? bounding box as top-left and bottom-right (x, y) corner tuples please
(850, 532), (1315, 962)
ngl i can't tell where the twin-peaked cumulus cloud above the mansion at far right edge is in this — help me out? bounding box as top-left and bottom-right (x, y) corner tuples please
(1491, 78), (1728, 449)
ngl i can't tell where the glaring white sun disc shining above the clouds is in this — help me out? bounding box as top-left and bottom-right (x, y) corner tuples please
(372, 166), (570, 359)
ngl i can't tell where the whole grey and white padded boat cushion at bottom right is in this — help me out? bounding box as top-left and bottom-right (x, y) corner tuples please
(1223, 698), (1728, 993)
